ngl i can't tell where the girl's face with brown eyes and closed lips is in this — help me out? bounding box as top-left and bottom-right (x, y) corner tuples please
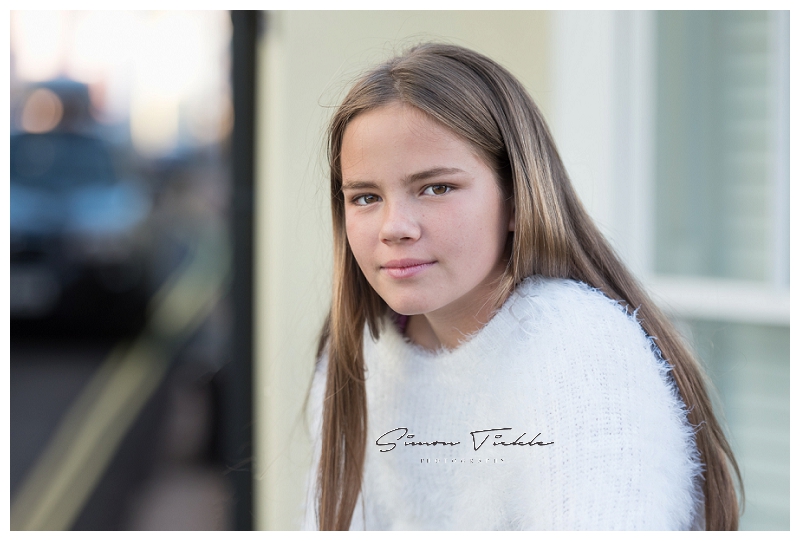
(341, 103), (514, 317)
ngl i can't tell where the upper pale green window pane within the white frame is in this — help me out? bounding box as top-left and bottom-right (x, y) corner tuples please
(656, 11), (776, 280)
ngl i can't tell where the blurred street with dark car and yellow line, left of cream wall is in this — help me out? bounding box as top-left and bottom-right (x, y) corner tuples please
(10, 11), (255, 530)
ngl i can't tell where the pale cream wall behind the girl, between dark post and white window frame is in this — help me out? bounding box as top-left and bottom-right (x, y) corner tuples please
(254, 11), (551, 530)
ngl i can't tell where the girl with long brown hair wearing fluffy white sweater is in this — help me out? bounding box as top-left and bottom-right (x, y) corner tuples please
(306, 44), (741, 530)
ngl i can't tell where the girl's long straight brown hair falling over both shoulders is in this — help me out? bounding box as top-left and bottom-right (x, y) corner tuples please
(317, 43), (741, 530)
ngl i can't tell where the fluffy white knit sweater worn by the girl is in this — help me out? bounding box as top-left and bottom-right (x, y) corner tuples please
(304, 277), (704, 530)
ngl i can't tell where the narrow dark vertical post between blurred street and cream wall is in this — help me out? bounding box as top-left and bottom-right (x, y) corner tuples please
(225, 11), (259, 530)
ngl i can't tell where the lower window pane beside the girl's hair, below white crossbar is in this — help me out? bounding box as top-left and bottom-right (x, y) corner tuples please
(684, 321), (789, 530)
